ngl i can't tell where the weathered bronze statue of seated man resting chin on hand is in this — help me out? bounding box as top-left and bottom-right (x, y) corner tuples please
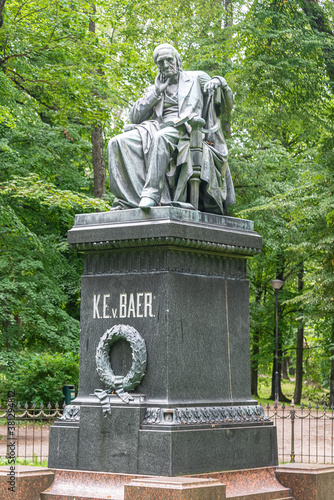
(108, 44), (235, 214)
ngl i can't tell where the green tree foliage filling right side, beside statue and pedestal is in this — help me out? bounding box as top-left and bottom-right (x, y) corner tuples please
(224, 0), (334, 397)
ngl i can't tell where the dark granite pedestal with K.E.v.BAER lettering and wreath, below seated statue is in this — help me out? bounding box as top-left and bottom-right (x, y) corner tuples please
(49, 207), (277, 476)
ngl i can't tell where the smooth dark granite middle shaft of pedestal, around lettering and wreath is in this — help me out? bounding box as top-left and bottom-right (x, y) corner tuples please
(75, 273), (252, 405)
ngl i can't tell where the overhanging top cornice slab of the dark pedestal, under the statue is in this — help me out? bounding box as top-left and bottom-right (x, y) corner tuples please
(68, 207), (262, 254)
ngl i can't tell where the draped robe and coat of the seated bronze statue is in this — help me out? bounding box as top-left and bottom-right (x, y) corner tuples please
(108, 71), (235, 214)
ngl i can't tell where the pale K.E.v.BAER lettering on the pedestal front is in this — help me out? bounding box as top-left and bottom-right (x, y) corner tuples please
(93, 292), (155, 319)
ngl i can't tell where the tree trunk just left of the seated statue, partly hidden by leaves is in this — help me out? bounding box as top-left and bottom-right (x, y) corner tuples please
(88, 4), (106, 198)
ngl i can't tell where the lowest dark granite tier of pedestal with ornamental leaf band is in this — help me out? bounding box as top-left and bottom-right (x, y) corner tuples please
(49, 394), (277, 476)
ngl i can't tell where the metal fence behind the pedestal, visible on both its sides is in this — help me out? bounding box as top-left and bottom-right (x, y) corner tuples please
(0, 403), (334, 465)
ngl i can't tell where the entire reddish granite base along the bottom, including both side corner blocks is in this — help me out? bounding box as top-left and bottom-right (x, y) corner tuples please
(0, 463), (334, 500)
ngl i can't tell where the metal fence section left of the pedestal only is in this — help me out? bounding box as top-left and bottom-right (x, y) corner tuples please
(0, 403), (65, 465)
